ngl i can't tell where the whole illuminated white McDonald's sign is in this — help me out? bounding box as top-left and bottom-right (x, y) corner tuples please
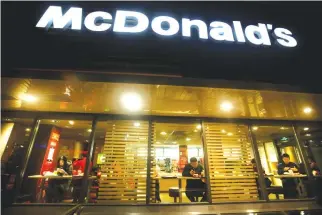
(36, 6), (297, 47)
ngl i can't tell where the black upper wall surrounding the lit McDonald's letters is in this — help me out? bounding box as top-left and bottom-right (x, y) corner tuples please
(1, 2), (322, 93)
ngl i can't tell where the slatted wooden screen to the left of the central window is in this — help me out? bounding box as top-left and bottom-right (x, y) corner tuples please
(98, 120), (149, 204)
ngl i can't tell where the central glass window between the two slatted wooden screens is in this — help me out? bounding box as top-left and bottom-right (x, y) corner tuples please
(150, 122), (208, 203)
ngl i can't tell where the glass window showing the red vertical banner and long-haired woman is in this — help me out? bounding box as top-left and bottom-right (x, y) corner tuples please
(17, 119), (92, 203)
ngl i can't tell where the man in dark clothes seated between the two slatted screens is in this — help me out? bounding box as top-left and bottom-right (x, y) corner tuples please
(182, 157), (207, 202)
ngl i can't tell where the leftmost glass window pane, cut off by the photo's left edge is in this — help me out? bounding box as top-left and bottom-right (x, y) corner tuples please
(0, 118), (33, 207)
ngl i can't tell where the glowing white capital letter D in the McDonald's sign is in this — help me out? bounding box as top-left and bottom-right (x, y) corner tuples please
(113, 10), (149, 33)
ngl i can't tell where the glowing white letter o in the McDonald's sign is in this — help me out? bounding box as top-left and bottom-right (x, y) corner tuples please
(151, 16), (180, 36)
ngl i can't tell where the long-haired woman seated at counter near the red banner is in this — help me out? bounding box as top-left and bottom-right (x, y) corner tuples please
(46, 156), (71, 203)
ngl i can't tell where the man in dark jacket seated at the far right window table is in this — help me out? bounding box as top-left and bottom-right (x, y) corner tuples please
(277, 154), (299, 199)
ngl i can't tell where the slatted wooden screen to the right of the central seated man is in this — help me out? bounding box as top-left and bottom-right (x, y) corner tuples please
(204, 123), (258, 202)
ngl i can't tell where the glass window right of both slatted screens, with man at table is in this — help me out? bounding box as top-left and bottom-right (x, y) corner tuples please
(252, 125), (307, 200)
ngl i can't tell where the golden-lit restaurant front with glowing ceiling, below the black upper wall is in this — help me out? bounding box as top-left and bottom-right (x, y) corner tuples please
(1, 78), (322, 204)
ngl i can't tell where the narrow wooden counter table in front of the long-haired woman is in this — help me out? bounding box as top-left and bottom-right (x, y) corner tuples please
(28, 175), (97, 202)
